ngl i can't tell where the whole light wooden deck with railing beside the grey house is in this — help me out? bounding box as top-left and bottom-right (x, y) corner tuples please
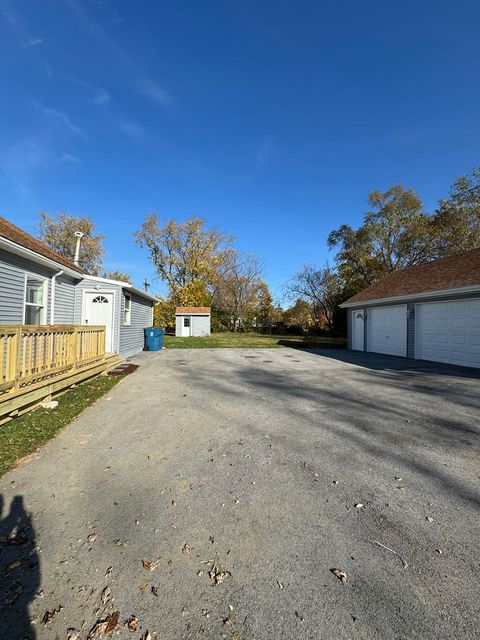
(0, 325), (118, 424)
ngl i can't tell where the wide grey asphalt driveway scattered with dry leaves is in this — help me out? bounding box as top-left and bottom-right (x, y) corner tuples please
(0, 349), (480, 640)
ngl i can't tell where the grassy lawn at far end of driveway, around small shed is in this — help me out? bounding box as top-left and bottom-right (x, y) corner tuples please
(164, 333), (345, 349)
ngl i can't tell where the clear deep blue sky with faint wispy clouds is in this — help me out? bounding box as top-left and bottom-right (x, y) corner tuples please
(0, 0), (480, 294)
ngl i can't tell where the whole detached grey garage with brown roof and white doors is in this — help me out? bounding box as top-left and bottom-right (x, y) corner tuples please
(341, 249), (480, 367)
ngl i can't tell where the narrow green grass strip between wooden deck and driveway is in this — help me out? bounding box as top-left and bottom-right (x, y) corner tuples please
(0, 376), (122, 476)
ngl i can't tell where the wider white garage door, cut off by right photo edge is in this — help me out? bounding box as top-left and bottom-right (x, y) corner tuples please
(415, 298), (480, 367)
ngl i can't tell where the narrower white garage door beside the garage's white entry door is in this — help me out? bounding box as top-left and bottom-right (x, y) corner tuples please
(367, 304), (407, 357)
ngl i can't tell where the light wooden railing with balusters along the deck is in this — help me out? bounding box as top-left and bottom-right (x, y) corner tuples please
(0, 325), (105, 398)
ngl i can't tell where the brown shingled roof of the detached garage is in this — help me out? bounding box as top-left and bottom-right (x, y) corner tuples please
(341, 249), (480, 307)
